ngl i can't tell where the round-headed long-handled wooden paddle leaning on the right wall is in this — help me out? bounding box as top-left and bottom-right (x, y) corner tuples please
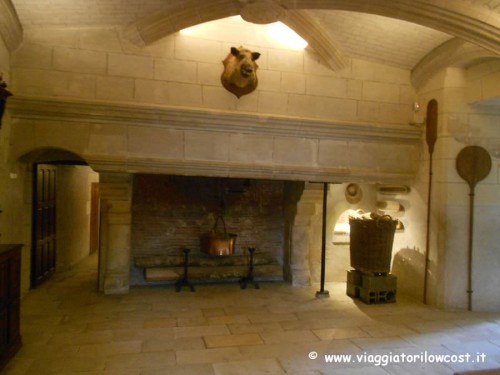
(456, 146), (491, 311)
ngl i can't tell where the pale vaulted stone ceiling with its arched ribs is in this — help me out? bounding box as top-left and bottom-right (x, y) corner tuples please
(4, 0), (500, 86)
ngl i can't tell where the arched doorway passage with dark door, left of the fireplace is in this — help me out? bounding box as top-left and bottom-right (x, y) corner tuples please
(20, 149), (99, 288)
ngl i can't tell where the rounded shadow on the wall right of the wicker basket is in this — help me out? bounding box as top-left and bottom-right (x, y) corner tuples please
(392, 248), (425, 299)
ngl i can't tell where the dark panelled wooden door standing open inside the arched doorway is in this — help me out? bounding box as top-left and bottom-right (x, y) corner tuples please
(31, 164), (57, 288)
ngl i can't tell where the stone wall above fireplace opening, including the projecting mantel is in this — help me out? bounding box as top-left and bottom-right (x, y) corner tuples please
(7, 19), (420, 181)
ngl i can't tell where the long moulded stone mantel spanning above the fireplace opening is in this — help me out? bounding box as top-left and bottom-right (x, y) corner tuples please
(7, 96), (421, 183)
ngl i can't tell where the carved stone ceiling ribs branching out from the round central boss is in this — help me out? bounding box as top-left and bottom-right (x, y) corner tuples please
(124, 0), (500, 70)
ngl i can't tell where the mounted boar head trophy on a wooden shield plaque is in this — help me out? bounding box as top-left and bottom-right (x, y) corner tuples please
(220, 47), (260, 98)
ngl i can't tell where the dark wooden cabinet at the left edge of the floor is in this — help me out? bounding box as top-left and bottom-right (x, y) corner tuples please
(0, 245), (22, 370)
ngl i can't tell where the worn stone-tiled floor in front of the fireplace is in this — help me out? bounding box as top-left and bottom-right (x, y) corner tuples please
(0, 257), (500, 375)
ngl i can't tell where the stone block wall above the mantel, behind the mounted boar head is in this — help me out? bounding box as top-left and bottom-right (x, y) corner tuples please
(13, 19), (415, 125)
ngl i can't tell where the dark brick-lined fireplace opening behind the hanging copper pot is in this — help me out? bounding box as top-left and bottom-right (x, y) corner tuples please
(131, 174), (301, 285)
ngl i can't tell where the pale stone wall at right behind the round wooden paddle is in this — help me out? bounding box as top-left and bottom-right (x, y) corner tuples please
(414, 67), (500, 311)
